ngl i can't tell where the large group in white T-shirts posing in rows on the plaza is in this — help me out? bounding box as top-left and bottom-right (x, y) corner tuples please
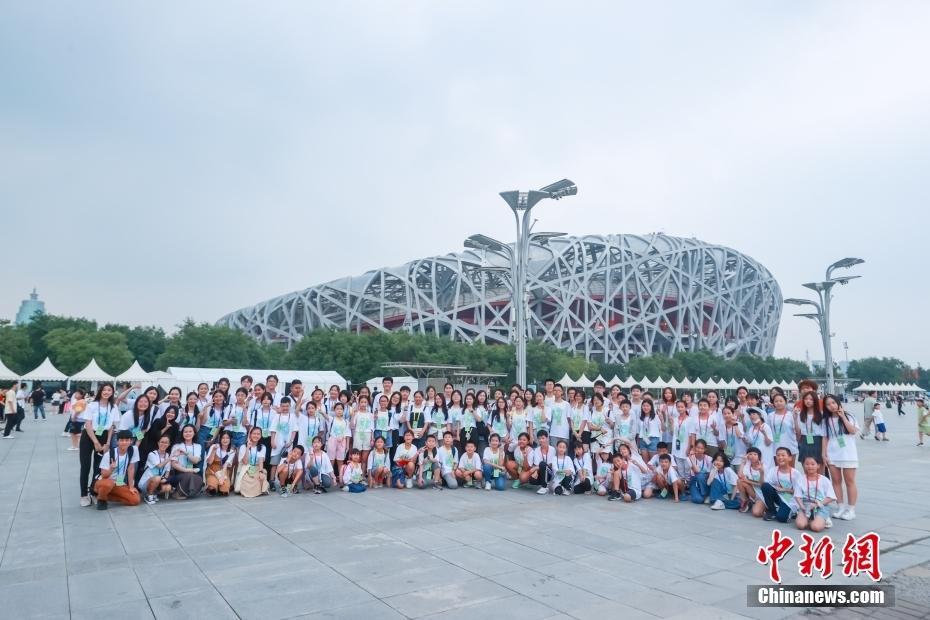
(69, 375), (860, 531)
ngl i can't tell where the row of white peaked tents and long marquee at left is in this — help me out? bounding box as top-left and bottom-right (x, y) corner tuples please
(0, 357), (348, 392)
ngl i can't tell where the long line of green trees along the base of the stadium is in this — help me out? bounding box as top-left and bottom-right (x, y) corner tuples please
(0, 314), (930, 387)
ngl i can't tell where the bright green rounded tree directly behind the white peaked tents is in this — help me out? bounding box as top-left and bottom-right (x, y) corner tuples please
(44, 327), (132, 375)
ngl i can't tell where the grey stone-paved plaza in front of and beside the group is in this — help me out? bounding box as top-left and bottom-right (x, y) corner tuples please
(0, 404), (930, 620)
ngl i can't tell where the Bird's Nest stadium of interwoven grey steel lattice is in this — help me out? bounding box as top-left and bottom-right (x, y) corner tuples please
(219, 234), (782, 362)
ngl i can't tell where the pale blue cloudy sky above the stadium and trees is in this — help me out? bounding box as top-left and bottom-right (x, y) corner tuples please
(0, 0), (930, 365)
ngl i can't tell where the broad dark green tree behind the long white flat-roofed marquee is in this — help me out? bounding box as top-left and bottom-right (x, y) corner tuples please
(155, 319), (265, 368)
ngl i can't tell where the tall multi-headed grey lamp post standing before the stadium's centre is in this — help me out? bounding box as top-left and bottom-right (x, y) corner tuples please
(465, 179), (578, 387)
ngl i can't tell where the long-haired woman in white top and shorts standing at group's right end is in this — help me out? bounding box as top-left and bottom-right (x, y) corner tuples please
(823, 394), (859, 521)
